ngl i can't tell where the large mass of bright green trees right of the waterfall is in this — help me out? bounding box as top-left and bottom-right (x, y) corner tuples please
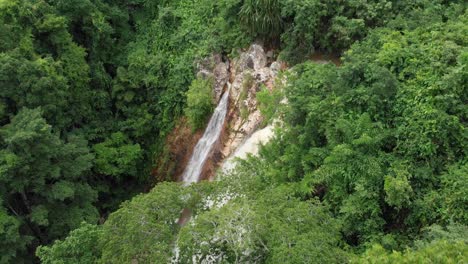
(258, 11), (467, 253)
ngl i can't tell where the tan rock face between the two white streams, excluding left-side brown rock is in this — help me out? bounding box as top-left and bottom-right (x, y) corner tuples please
(200, 44), (285, 182)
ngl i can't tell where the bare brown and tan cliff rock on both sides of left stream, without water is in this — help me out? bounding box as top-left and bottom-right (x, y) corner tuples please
(155, 44), (285, 183)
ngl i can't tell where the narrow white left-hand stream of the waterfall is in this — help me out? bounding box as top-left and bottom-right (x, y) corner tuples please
(182, 89), (229, 184)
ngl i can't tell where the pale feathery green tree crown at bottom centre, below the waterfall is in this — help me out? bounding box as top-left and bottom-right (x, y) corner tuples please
(177, 183), (344, 263)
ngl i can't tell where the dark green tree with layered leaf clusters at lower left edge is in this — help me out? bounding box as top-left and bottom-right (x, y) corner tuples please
(0, 108), (98, 256)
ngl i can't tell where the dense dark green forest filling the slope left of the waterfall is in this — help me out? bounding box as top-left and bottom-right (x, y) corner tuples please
(0, 0), (250, 262)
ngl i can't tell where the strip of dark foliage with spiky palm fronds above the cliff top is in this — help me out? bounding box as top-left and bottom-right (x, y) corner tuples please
(238, 0), (463, 63)
